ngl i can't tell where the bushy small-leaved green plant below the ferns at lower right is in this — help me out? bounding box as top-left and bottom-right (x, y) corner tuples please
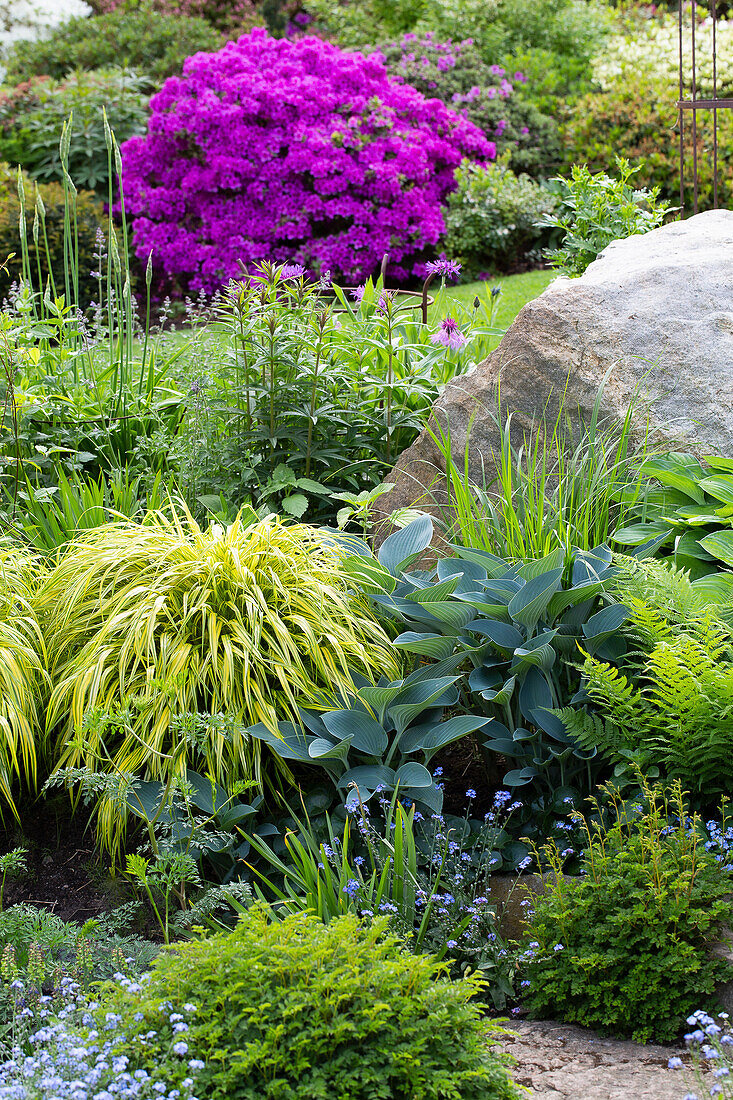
(524, 785), (733, 1042)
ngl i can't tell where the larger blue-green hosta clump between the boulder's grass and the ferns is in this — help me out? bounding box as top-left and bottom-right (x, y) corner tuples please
(338, 516), (628, 827)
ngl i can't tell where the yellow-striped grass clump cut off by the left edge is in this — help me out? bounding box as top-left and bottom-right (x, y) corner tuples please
(0, 542), (47, 816)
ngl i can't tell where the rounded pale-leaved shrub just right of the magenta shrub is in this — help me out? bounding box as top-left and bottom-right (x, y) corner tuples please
(445, 160), (557, 277)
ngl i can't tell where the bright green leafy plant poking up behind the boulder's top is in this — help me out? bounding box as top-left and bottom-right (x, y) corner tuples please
(541, 156), (669, 275)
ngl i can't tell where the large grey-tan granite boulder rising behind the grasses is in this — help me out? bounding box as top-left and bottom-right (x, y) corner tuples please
(380, 210), (733, 512)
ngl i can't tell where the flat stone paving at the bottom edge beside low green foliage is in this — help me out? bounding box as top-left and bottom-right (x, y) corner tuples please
(502, 1020), (693, 1100)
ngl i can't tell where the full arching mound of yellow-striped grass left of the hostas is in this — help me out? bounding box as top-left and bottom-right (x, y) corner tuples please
(40, 512), (397, 800)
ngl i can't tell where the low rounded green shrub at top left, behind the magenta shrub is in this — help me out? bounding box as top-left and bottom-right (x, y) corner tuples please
(6, 8), (221, 84)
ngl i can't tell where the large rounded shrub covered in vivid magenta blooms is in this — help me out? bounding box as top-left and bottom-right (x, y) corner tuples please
(122, 28), (496, 292)
